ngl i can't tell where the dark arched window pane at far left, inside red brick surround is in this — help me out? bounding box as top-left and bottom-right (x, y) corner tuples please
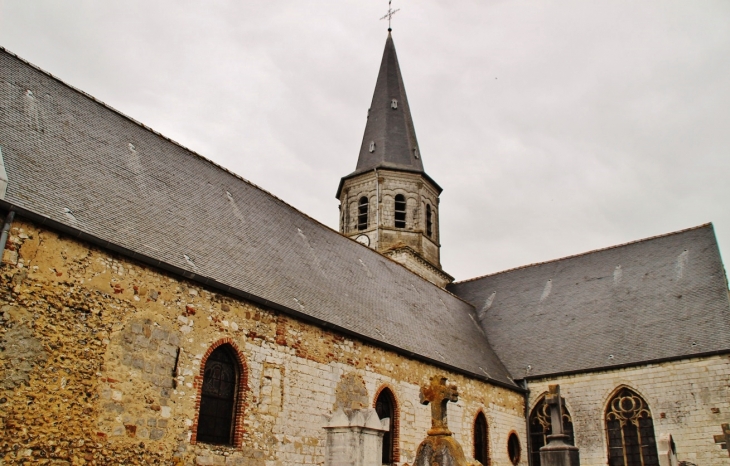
(195, 344), (241, 445)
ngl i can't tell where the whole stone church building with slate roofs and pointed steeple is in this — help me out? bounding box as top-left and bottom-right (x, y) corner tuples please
(0, 28), (730, 466)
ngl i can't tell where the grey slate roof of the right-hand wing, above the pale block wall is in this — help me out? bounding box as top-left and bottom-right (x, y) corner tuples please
(448, 224), (730, 379)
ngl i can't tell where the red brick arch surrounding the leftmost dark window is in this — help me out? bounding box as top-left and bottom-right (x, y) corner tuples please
(190, 338), (248, 448)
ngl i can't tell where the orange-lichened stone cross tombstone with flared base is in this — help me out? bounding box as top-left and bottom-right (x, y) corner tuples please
(413, 376), (480, 466)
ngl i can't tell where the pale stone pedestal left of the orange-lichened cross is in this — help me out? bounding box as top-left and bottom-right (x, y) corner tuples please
(324, 409), (390, 466)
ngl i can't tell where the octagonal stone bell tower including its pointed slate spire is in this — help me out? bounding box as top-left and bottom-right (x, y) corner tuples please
(337, 31), (454, 287)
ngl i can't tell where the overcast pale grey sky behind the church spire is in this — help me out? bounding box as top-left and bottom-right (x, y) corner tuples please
(0, 0), (730, 280)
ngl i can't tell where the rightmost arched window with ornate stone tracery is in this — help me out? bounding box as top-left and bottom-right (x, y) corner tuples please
(606, 388), (659, 466)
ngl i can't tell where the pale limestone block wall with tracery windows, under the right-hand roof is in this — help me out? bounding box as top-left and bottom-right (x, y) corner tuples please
(528, 355), (730, 466)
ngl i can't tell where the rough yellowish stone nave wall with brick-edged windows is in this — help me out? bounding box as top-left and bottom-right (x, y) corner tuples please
(0, 219), (527, 466)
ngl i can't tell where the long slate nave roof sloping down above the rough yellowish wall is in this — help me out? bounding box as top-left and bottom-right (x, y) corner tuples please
(0, 49), (515, 388)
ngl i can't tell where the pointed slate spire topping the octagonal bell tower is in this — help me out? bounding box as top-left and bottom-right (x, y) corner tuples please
(355, 32), (423, 173)
